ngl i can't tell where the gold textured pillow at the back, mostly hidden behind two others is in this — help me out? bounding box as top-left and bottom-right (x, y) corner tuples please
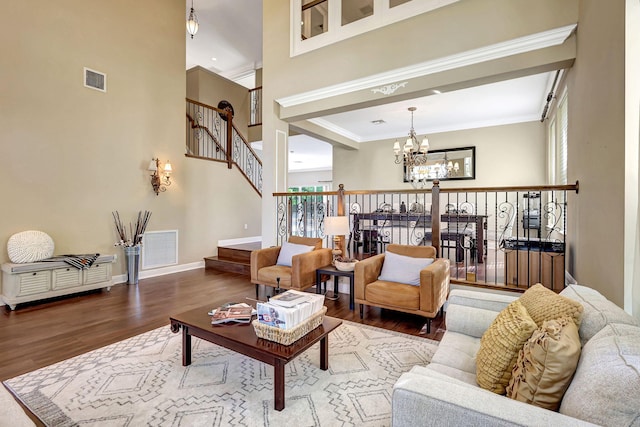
(519, 283), (583, 327)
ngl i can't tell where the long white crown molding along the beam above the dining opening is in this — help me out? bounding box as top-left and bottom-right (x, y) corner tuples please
(276, 24), (577, 108)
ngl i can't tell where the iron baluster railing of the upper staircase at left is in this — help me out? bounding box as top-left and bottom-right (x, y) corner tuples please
(186, 99), (262, 195)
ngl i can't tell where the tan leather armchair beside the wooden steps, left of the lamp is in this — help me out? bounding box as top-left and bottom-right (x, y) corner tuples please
(251, 236), (332, 298)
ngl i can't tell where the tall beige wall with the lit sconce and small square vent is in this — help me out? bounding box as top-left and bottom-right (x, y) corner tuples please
(0, 0), (260, 284)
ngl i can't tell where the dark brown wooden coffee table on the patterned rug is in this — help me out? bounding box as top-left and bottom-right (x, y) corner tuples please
(170, 306), (342, 411)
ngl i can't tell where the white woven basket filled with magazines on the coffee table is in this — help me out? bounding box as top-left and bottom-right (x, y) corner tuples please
(257, 290), (324, 329)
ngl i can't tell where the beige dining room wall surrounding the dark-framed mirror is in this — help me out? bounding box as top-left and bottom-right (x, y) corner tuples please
(333, 122), (546, 190)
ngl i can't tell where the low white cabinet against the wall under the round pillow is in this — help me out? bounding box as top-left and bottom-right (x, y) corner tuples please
(0, 255), (116, 310)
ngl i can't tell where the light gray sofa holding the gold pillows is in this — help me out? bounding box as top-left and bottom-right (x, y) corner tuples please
(392, 285), (640, 427)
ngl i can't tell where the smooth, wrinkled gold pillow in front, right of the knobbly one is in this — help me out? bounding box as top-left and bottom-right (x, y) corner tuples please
(507, 317), (580, 411)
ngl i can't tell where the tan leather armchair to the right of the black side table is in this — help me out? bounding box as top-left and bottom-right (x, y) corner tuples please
(354, 244), (450, 333)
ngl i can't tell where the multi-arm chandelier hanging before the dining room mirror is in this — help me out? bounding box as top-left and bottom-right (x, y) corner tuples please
(393, 107), (429, 189)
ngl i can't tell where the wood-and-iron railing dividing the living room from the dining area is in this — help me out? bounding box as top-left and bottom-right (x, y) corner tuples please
(274, 181), (578, 291)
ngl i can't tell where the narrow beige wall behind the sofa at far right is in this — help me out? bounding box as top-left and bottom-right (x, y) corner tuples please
(568, 0), (637, 306)
